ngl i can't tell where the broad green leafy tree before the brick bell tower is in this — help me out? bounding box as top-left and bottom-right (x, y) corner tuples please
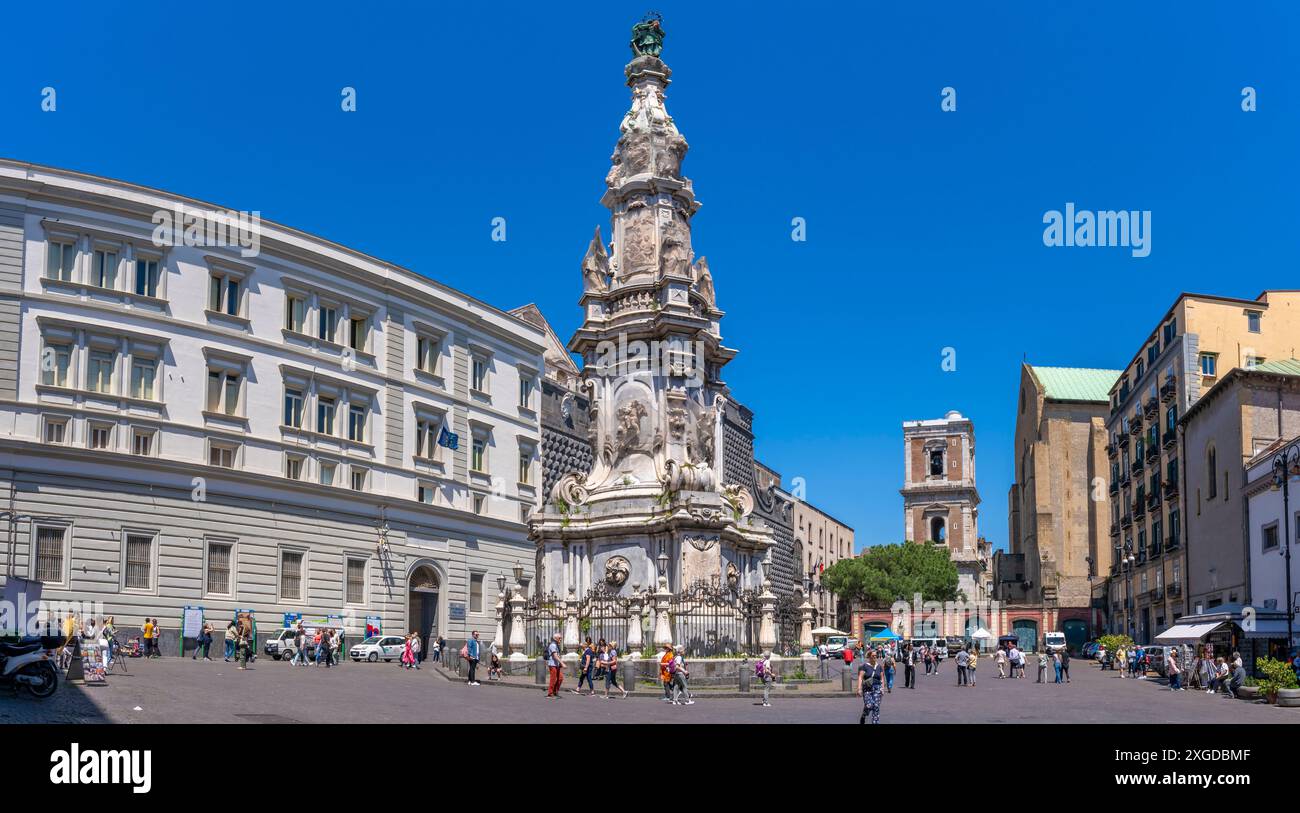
(822, 542), (962, 609)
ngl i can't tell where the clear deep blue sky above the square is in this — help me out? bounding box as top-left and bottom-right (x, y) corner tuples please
(0, 0), (1300, 546)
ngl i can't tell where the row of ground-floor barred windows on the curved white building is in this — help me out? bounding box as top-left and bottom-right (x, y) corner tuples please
(33, 526), (484, 613)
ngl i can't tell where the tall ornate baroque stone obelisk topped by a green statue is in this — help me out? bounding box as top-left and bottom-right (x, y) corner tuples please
(529, 17), (774, 608)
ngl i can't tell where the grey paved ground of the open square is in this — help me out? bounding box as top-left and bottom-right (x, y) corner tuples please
(0, 657), (1300, 725)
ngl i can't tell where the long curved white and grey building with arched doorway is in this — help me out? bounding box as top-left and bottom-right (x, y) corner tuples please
(0, 161), (543, 650)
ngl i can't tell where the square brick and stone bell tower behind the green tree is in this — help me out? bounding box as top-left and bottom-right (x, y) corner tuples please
(900, 410), (983, 601)
